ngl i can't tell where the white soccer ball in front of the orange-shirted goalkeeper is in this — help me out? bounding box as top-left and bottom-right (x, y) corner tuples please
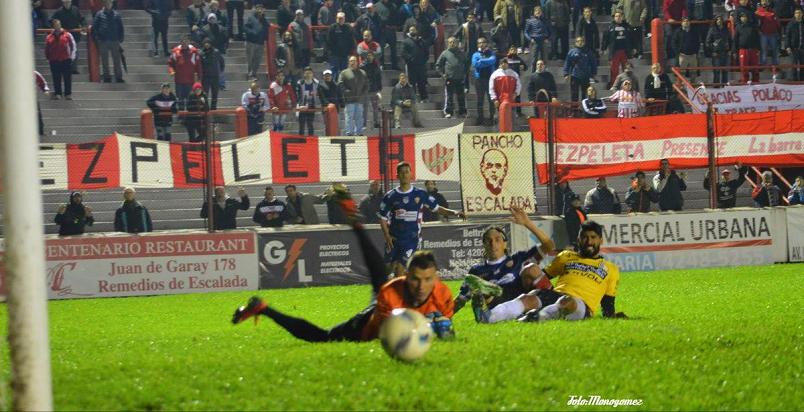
(380, 309), (433, 362)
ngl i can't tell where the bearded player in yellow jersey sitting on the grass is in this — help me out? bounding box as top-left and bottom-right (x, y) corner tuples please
(464, 220), (626, 323)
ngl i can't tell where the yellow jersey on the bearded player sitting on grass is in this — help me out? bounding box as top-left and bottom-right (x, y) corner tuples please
(544, 250), (620, 315)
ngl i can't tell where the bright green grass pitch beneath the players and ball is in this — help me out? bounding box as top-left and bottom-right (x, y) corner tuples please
(0, 264), (804, 410)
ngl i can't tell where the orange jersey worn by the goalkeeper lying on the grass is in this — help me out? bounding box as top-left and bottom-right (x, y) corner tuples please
(363, 277), (454, 340)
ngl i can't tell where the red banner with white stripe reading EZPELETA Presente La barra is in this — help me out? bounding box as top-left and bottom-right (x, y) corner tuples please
(530, 111), (804, 184)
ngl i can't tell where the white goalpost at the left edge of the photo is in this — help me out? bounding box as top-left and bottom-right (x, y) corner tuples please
(0, 4), (53, 411)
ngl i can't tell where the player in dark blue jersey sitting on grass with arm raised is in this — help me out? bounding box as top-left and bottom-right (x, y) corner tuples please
(455, 207), (555, 320)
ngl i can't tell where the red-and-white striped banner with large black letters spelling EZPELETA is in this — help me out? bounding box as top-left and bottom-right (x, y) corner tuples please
(39, 125), (462, 190)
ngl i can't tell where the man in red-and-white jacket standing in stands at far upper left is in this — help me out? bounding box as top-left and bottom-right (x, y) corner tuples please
(45, 19), (75, 100)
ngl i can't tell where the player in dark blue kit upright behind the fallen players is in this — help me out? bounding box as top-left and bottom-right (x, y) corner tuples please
(378, 162), (464, 268)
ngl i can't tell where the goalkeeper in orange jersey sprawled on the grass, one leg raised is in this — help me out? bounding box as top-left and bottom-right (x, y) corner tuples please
(232, 192), (453, 342)
